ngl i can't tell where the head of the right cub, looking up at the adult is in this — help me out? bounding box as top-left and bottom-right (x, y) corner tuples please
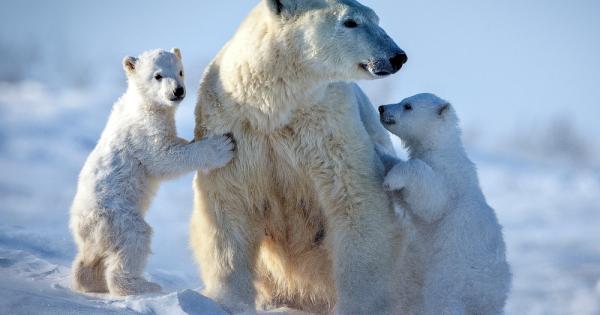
(379, 93), (460, 149)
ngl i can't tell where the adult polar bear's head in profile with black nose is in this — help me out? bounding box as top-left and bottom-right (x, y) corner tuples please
(263, 0), (407, 81)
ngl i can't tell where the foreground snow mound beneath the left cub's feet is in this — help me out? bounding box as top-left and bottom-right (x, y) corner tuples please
(0, 244), (227, 315)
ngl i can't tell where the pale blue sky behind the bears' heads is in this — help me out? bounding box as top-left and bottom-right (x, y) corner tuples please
(0, 0), (600, 143)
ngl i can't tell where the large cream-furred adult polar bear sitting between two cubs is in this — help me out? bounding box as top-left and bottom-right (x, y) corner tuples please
(190, 0), (407, 314)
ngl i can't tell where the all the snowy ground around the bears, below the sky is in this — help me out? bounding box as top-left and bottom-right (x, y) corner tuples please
(0, 82), (600, 315)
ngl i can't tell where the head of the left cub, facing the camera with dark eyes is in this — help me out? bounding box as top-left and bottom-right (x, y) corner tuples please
(123, 48), (185, 107)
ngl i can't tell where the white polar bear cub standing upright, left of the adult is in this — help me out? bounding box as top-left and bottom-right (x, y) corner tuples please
(70, 48), (234, 296)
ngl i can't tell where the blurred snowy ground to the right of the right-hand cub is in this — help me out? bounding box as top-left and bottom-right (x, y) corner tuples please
(476, 159), (600, 314)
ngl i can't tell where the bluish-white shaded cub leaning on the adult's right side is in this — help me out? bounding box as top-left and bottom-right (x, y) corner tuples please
(379, 94), (511, 315)
